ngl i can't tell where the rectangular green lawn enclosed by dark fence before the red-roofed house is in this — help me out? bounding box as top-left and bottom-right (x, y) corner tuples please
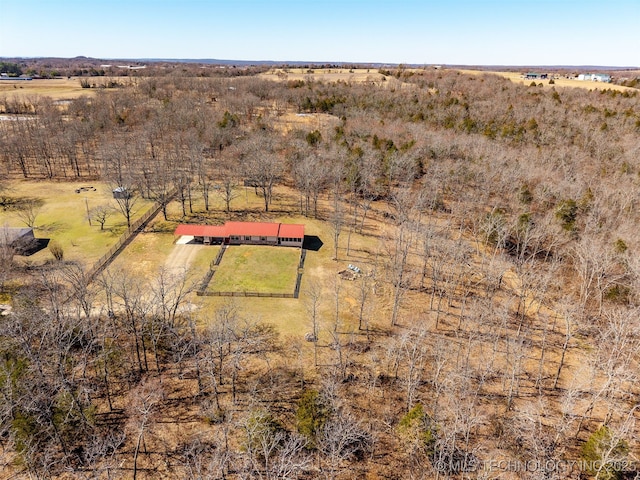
(209, 245), (300, 293)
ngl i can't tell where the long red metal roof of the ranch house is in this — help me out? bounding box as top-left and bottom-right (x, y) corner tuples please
(174, 222), (304, 238)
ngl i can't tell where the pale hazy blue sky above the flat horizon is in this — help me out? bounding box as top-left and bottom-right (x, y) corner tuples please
(0, 0), (640, 66)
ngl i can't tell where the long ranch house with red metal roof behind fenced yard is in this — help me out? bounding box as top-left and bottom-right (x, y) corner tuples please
(175, 222), (304, 247)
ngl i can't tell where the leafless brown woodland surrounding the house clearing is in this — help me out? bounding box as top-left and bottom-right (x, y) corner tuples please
(0, 62), (640, 479)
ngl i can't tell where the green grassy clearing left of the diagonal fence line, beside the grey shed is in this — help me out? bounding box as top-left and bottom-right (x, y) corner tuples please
(0, 181), (151, 266)
